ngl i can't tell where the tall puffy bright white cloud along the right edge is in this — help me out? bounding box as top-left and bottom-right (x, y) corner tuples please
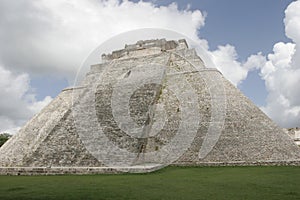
(261, 1), (300, 127)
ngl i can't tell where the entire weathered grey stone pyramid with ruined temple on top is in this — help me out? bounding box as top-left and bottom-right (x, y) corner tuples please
(0, 39), (300, 174)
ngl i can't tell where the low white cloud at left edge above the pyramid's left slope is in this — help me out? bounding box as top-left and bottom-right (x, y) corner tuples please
(0, 65), (52, 133)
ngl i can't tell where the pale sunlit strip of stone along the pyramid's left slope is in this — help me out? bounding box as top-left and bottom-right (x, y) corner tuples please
(0, 91), (72, 166)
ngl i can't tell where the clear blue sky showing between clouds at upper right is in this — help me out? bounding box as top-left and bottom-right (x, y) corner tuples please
(189, 0), (292, 106)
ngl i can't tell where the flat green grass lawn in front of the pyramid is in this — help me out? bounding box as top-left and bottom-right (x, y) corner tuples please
(0, 167), (300, 200)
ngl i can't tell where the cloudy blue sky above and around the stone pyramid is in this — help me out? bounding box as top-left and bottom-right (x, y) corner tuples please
(0, 0), (300, 133)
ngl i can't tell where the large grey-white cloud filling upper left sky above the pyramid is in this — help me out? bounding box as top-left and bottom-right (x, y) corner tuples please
(0, 0), (205, 78)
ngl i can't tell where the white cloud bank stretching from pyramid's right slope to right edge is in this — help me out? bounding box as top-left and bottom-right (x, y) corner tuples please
(208, 0), (300, 127)
